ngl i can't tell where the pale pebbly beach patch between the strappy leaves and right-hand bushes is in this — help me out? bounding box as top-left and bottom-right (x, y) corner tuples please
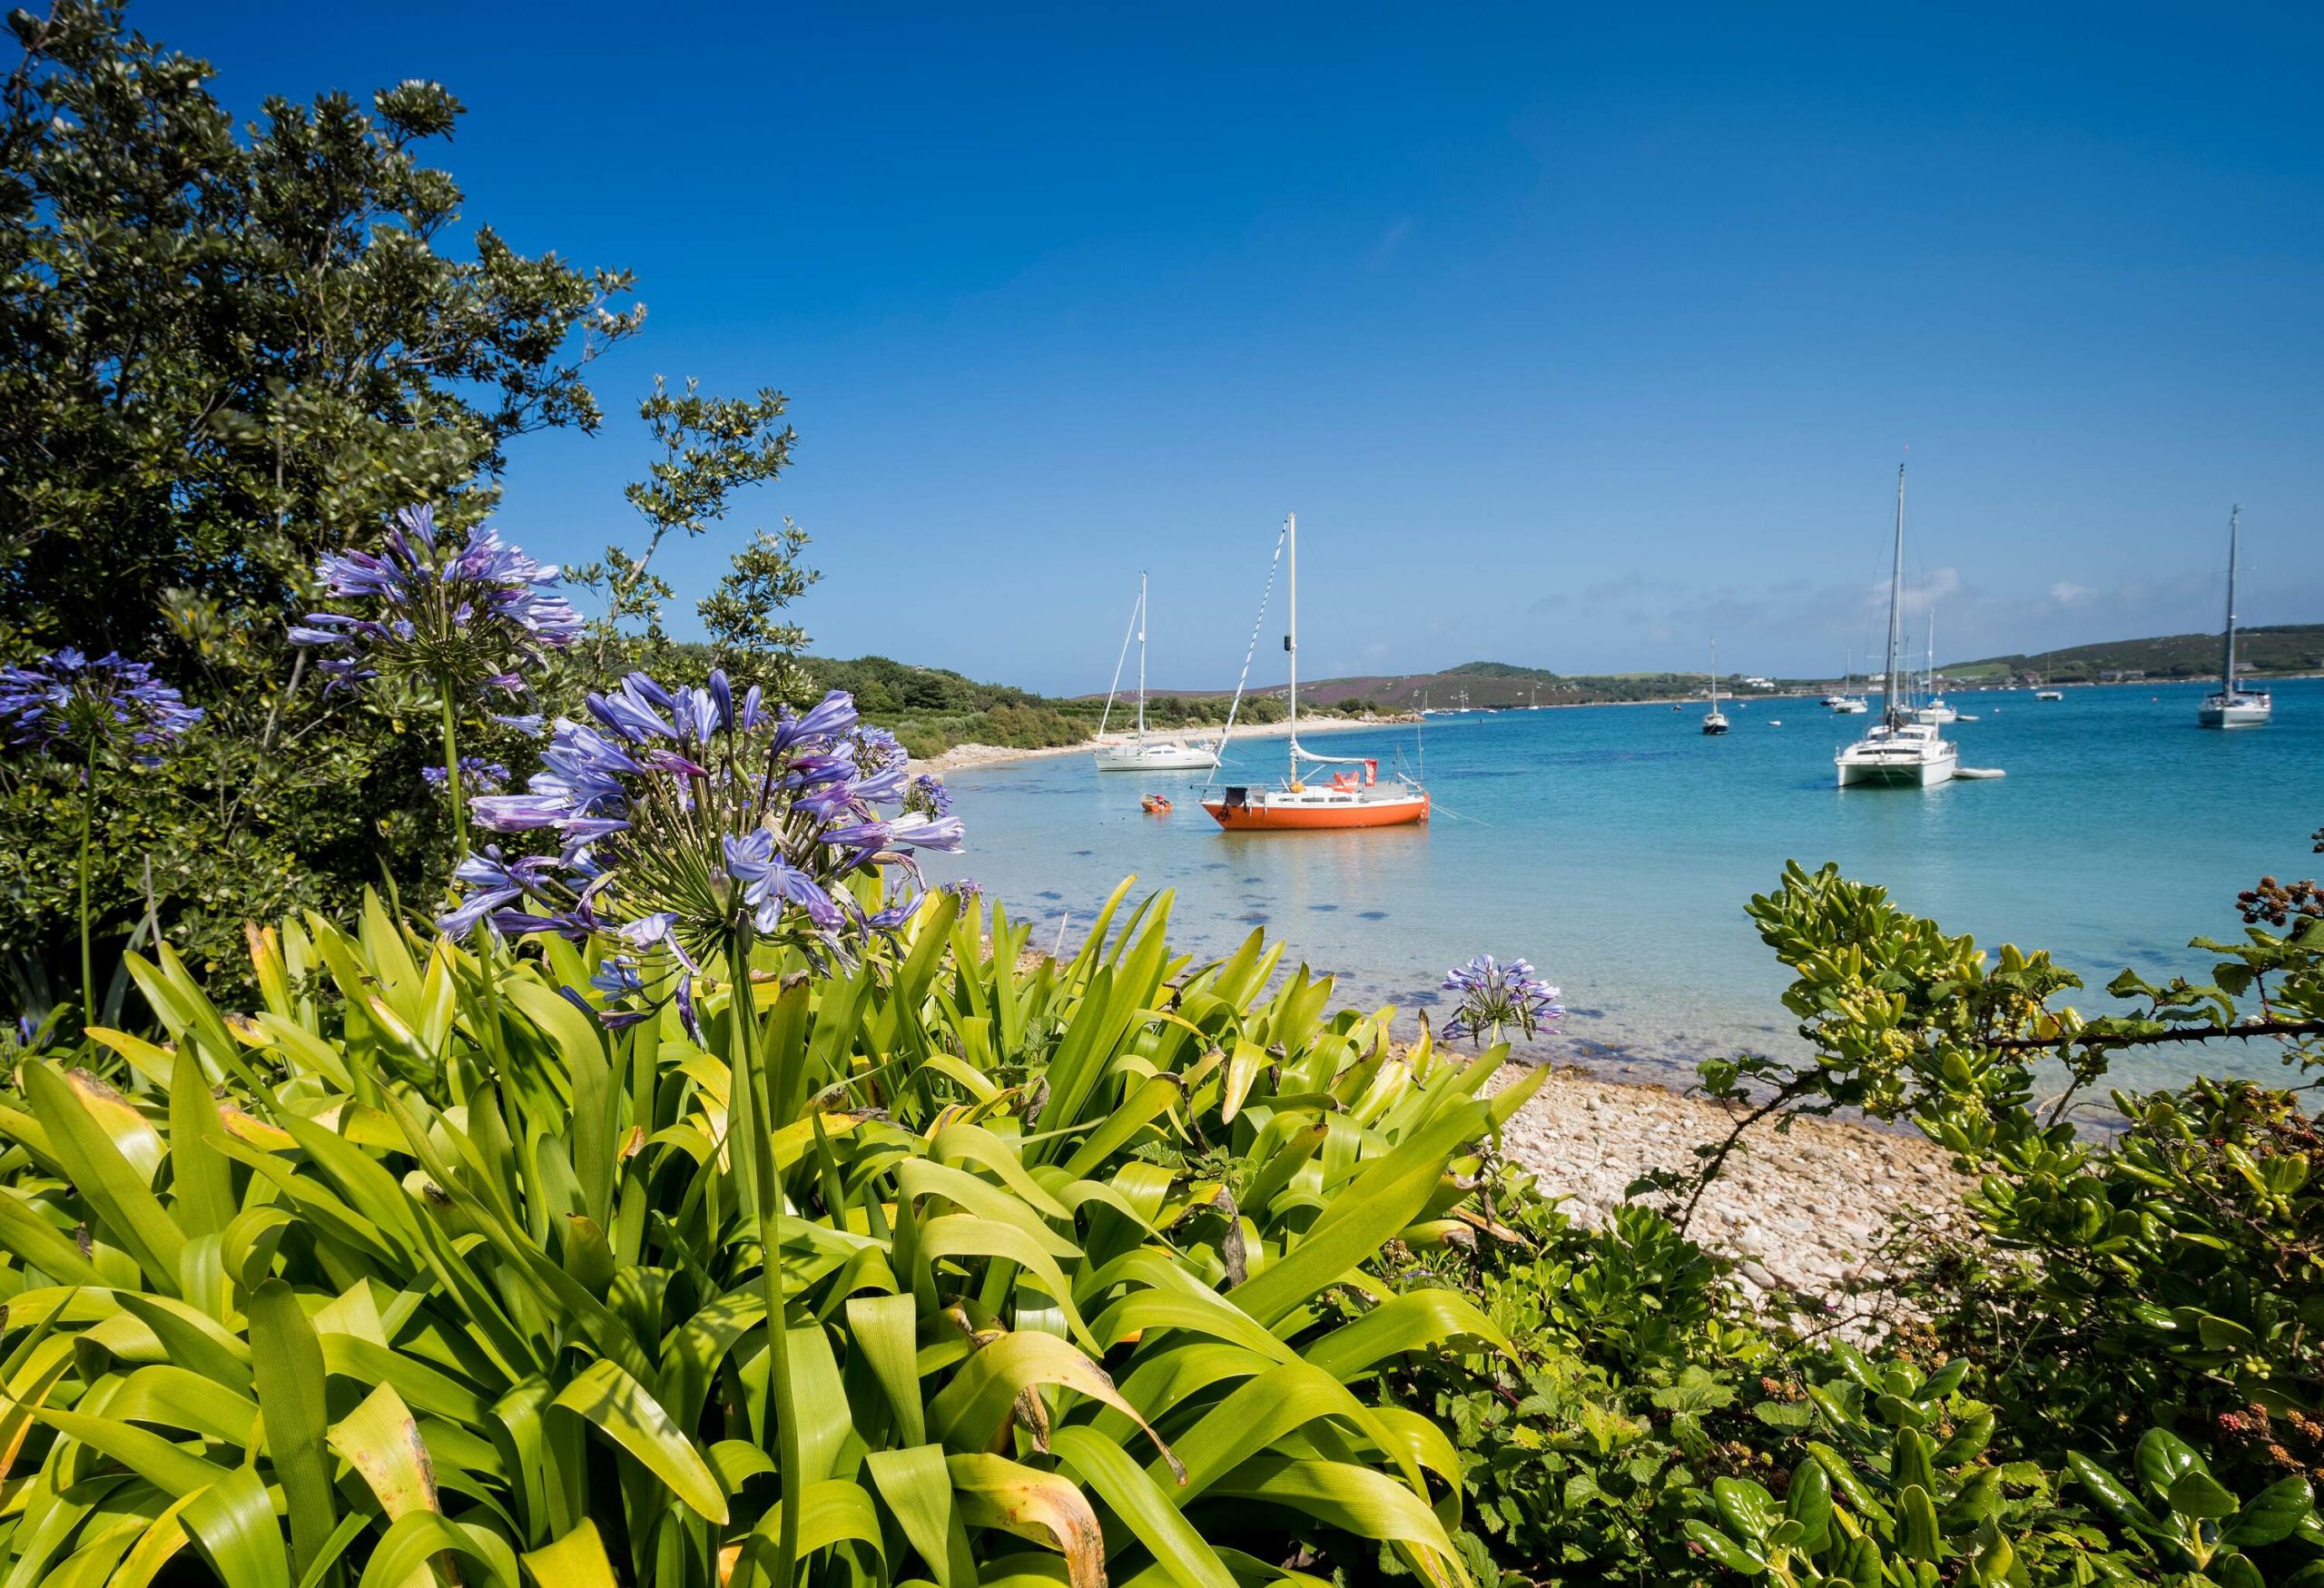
(1503, 1070), (1968, 1335)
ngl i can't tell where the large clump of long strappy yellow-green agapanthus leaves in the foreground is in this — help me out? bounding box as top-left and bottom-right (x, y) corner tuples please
(0, 897), (1524, 1588)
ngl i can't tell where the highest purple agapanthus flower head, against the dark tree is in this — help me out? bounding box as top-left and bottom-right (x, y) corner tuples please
(290, 505), (581, 693)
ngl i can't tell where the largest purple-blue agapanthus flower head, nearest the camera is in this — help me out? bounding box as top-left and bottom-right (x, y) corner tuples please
(439, 672), (962, 1031)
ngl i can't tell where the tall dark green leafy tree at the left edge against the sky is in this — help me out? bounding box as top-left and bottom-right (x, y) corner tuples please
(0, 0), (644, 1002)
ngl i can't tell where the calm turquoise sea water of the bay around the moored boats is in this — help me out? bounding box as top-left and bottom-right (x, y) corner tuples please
(934, 679), (2324, 1083)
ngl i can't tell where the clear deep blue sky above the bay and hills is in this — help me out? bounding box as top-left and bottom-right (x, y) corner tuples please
(154, 0), (2324, 691)
